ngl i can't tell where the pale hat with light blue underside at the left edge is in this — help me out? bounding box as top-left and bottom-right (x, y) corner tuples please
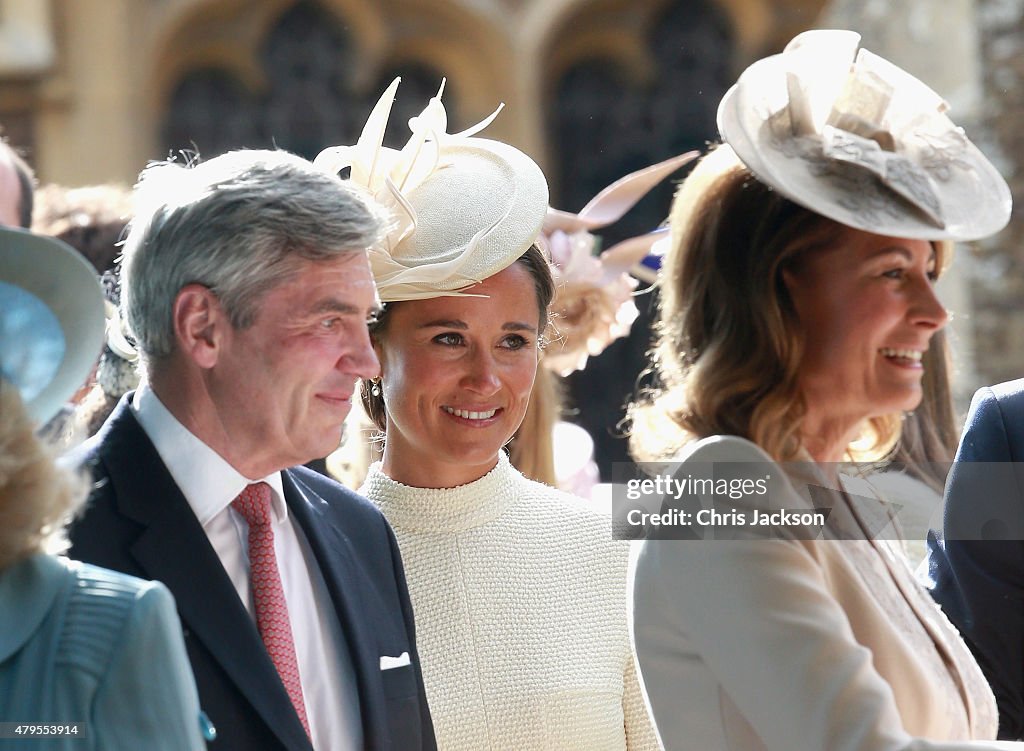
(0, 227), (104, 424)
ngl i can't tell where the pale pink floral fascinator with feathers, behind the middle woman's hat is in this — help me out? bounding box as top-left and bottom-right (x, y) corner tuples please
(540, 152), (698, 376)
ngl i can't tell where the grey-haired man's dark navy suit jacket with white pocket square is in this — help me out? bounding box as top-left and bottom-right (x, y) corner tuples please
(70, 394), (435, 751)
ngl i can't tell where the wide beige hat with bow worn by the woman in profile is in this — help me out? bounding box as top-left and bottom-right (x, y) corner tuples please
(718, 31), (1011, 241)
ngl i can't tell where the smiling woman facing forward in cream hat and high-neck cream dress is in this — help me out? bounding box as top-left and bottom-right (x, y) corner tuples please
(316, 81), (659, 751)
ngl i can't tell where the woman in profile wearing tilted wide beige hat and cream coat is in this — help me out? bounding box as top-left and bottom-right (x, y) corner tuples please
(632, 31), (1010, 751)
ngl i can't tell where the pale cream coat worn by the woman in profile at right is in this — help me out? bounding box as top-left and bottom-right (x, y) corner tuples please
(633, 436), (1024, 751)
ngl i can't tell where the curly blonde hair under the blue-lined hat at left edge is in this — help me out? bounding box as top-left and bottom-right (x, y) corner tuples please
(0, 379), (88, 571)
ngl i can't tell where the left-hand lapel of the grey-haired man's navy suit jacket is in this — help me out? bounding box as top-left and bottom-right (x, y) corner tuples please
(100, 401), (309, 748)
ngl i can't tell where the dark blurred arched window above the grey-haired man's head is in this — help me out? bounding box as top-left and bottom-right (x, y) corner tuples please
(160, 0), (453, 158)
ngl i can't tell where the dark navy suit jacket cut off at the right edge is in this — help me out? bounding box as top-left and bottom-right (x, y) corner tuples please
(928, 380), (1024, 739)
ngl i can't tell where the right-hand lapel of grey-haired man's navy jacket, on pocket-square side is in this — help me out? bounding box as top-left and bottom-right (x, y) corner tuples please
(283, 470), (387, 749)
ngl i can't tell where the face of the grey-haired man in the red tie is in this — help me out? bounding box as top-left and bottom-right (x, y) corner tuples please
(199, 252), (380, 469)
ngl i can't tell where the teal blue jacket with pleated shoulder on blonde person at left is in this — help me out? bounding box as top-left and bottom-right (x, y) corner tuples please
(0, 554), (206, 751)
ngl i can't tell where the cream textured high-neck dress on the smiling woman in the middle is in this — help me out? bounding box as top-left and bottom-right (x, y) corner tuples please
(360, 454), (660, 751)
